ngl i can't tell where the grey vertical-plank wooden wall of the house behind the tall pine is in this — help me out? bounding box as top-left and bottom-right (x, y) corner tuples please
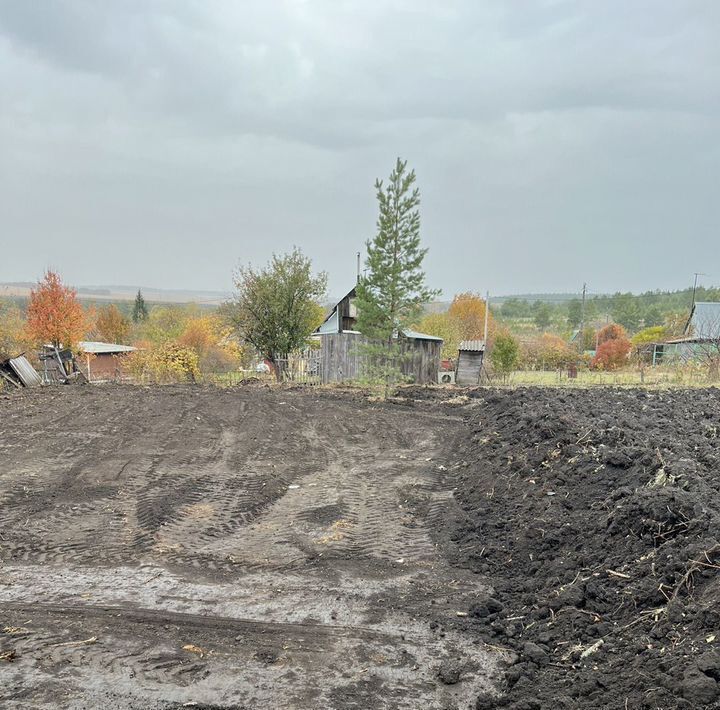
(321, 333), (442, 384)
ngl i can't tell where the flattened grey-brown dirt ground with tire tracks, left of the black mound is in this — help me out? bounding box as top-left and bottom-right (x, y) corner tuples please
(0, 386), (504, 710)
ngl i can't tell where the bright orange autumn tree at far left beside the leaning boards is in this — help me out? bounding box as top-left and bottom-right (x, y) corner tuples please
(27, 270), (85, 347)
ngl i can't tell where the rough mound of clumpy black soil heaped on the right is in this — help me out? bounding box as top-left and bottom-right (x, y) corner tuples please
(451, 389), (720, 710)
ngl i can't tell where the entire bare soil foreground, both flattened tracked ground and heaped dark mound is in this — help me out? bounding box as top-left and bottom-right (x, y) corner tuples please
(0, 386), (720, 710)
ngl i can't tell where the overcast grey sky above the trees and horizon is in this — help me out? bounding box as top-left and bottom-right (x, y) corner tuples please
(0, 0), (720, 296)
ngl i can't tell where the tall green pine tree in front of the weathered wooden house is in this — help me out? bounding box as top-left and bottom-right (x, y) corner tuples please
(356, 158), (440, 347)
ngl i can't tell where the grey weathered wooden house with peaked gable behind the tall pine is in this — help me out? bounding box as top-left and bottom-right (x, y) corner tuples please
(314, 287), (443, 384)
